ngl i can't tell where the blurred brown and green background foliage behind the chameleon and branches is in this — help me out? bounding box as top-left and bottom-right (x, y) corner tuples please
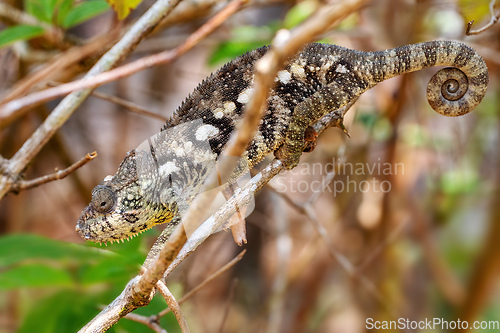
(0, 0), (500, 332)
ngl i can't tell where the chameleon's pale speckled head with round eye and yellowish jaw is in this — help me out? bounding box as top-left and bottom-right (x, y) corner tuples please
(76, 150), (172, 243)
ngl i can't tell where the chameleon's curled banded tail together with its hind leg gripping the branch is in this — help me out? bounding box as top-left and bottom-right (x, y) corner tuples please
(275, 41), (488, 169)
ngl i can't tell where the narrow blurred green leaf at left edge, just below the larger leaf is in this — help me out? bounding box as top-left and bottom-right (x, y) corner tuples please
(0, 264), (72, 290)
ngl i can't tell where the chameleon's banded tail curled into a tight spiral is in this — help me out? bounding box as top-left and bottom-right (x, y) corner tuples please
(367, 41), (489, 117)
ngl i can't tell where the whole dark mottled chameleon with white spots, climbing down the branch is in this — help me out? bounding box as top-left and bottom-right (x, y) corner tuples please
(76, 41), (488, 260)
